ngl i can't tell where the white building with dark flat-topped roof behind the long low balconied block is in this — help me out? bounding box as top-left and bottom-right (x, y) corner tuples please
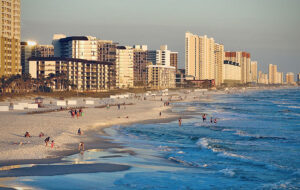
(52, 34), (98, 61)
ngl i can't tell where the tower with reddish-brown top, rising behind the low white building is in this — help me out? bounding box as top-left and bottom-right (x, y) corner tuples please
(225, 51), (252, 84)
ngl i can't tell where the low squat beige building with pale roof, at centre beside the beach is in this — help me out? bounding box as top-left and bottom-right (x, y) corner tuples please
(147, 65), (176, 89)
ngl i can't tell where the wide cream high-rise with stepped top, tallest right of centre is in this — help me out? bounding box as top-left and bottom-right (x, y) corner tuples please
(185, 32), (216, 80)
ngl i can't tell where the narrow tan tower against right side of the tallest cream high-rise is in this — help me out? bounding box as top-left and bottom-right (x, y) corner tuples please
(215, 43), (225, 86)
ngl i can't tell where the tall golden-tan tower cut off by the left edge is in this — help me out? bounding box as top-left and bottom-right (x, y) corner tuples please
(0, 0), (21, 77)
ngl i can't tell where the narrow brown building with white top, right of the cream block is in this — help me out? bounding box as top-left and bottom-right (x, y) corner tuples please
(133, 45), (148, 87)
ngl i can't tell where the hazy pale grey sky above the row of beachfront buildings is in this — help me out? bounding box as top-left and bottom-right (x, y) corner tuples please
(21, 0), (300, 73)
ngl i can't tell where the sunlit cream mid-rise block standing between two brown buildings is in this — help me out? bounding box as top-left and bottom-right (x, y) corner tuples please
(116, 46), (134, 88)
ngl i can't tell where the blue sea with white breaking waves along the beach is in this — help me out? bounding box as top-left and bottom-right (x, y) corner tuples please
(2, 88), (300, 190)
